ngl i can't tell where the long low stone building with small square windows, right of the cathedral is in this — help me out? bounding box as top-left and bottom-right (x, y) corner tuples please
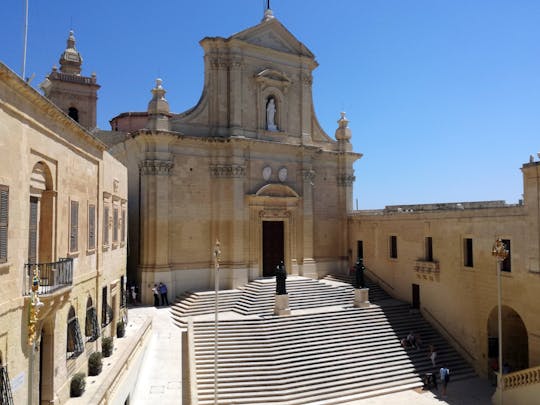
(349, 158), (540, 384)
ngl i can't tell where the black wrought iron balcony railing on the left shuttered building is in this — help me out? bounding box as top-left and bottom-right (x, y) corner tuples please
(24, 258), (73, 295)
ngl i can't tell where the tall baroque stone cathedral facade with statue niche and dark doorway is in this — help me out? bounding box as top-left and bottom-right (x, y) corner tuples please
(102, 9), (361, 303)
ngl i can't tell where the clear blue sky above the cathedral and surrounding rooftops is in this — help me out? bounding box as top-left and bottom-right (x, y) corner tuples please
(0, 0), (540, 209)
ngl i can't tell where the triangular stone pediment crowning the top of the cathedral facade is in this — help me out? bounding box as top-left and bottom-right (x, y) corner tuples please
(231, 18), (314, 59)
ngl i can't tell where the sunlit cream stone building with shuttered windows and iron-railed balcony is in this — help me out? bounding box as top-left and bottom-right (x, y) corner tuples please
(0, 45), (127, 404)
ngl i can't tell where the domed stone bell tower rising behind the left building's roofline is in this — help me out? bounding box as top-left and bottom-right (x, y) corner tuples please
(40, 31), (100, 130)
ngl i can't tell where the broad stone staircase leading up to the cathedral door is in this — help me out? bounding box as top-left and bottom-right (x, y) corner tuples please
(172, 277), (474, 405)
